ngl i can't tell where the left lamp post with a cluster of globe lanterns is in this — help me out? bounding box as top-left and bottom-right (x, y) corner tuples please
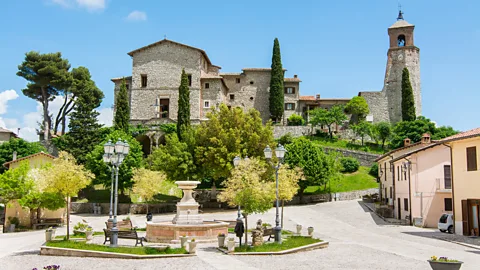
(103, 140), (130, 247)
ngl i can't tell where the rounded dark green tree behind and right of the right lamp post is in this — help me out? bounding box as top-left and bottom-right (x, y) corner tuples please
(285, 138), (340, 199)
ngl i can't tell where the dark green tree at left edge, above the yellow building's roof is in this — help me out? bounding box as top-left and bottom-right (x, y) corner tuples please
(0, 138), (47, 173)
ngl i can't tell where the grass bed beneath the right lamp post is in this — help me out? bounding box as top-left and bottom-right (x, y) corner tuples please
(235, 236), (322, 252)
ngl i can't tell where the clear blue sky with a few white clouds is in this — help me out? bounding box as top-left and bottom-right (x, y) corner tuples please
(0, 0), (480, 141)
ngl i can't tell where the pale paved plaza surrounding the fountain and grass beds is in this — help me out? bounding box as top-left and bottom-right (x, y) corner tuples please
(0, 201), (480, 270)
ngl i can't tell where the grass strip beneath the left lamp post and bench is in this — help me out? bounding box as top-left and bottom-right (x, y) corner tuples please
(47, 241), (188, 255)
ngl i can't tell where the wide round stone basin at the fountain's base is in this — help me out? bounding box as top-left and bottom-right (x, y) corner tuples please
(146, 221), (229, 243)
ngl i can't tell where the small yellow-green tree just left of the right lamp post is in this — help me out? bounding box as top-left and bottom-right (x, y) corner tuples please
(218, 158), (275, 245)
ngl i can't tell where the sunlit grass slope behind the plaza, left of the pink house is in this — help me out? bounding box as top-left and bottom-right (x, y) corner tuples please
(305, 166), (378, 194)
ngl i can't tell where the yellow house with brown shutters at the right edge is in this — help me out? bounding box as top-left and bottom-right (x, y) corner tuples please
(440, 128), (480, 236)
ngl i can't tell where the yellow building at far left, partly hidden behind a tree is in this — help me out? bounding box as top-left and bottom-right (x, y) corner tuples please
(3, 152), (66, 228)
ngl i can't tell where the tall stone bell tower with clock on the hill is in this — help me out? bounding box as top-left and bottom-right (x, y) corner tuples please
(359, 11), (422, 123)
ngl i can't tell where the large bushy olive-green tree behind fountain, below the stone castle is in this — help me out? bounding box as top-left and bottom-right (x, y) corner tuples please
(195, 104), (275, 181)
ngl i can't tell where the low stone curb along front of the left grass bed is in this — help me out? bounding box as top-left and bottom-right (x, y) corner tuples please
(40, 246), (197, 259)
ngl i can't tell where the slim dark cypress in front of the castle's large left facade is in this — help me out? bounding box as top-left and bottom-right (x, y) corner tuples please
(177, 69), (190, 140)
